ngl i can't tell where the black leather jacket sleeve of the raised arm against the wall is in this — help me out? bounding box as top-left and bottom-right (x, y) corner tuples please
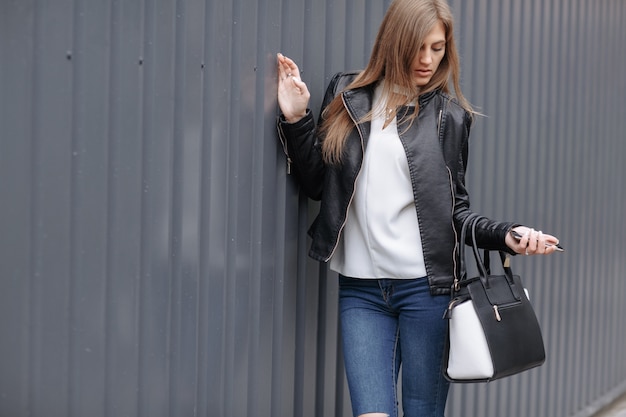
(277, 73), (341, 200)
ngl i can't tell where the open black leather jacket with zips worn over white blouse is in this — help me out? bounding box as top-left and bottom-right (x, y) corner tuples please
(278, 73), (514, 294)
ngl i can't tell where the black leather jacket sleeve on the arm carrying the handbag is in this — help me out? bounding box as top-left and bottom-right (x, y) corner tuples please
(454, 107), (517, 254)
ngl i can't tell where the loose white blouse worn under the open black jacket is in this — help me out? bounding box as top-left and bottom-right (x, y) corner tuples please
(330, 86), (426, 279)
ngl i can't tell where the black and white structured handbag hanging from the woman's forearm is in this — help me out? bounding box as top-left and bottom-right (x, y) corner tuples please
(443, 215), (546, 382)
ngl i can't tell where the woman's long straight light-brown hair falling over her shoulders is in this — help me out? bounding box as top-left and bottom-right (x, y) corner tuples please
(320, 0), (473, 164)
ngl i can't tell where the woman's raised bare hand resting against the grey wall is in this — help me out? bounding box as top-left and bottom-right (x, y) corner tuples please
(277, 54), (311, 123)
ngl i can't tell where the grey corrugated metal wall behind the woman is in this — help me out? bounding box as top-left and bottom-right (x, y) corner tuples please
(0, 0), (626, 417)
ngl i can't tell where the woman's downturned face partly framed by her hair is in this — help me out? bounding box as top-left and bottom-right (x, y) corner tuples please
(411, 22), (446, 87)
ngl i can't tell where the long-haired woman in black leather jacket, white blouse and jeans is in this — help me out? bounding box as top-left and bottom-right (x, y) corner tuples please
(278, 0), (558, 417)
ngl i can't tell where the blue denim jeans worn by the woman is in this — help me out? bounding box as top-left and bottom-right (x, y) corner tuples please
(339, 275), (450, 417)
